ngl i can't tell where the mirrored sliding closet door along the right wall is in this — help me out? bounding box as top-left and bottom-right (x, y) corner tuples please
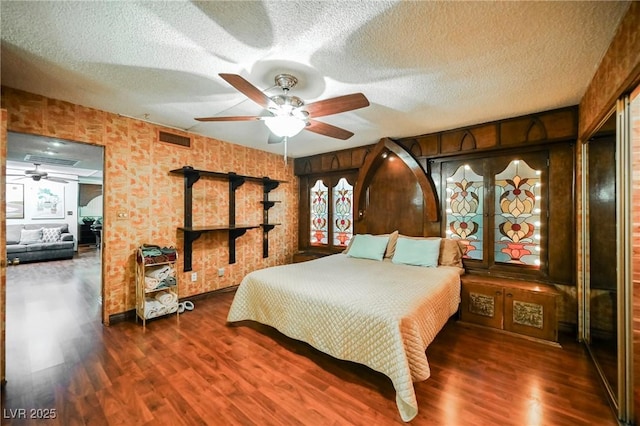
(582, 84), (640, 423)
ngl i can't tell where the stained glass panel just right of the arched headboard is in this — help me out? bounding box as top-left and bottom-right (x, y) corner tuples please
(446, 164), (484, 260)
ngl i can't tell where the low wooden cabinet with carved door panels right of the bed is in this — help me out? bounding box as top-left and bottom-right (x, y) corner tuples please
(460, 275), (560, 342)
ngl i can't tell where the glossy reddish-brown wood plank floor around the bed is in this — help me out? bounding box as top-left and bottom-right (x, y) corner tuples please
(2, 252), (617, 426)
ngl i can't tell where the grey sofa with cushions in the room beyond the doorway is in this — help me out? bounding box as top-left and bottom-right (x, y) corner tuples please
(7, 223), (75, 263)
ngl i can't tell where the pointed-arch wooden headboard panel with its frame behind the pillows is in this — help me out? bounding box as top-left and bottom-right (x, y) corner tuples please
(354, 138), (440, 236)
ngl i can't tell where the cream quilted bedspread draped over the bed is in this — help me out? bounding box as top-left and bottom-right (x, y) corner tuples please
(227, 238), (463, 421)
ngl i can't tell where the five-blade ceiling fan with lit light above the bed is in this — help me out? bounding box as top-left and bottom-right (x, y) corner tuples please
(196, 74), (369, 143)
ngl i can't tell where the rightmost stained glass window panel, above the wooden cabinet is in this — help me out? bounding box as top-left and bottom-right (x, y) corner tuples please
(494, 160), (541, 267)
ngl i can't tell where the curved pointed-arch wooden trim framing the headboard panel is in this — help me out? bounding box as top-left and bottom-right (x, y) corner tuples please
(354, 138), (439, 222)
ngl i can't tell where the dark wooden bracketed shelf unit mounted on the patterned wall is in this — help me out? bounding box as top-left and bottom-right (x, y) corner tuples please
(169, 166), (283, 272)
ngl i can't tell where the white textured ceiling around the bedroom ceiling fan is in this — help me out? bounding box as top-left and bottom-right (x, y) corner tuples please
(0, 1), (629, 157)
